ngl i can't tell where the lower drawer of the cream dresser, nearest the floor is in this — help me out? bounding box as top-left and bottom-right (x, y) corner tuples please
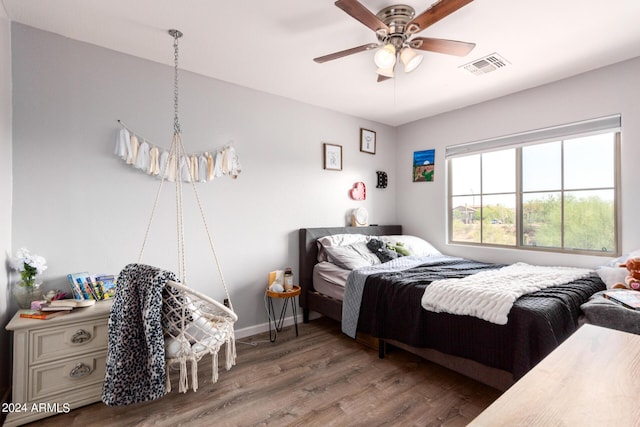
(28, 350), (107, 402)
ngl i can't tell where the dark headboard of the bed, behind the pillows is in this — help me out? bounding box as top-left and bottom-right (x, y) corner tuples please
(298, 225), (402, 322)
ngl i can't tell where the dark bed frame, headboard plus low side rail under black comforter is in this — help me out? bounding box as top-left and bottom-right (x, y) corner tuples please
(299, 225), (515, 390)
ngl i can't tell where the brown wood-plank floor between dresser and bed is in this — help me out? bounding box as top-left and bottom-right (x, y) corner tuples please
(32, 318), (500, 427)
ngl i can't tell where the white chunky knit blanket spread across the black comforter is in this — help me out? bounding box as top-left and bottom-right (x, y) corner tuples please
(422, 263), (591, 325)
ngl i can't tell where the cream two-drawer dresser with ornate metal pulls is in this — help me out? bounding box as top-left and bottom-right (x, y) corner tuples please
(3, 301), (112, 427)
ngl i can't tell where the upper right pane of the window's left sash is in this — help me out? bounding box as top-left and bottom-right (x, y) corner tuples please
(482, 148), (516, 194)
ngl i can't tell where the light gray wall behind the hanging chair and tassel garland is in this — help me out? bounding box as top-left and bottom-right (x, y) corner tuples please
(12, 24), (397, 328)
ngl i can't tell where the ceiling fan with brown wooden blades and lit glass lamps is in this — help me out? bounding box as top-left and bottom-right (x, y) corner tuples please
(313, 0), (476, 82)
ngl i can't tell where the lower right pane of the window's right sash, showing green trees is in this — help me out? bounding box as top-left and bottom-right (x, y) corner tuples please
(564, 190), (615, 252)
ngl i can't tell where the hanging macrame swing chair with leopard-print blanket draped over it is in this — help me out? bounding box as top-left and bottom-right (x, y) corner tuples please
(103, 30), (238, 405)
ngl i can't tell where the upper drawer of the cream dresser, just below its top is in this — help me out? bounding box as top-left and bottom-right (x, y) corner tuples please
(29, 319), (108, 365)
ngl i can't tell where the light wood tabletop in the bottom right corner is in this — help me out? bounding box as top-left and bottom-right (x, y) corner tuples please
(469, 325), (640, 427)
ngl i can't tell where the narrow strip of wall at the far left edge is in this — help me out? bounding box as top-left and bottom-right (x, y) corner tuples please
(0, 7), (12, 397)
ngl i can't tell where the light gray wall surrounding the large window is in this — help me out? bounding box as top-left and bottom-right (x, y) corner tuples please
(396, 58), (640, 266)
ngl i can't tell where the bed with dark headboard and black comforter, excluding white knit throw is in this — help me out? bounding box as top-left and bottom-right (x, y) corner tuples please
(299, 225), (605, 390)
